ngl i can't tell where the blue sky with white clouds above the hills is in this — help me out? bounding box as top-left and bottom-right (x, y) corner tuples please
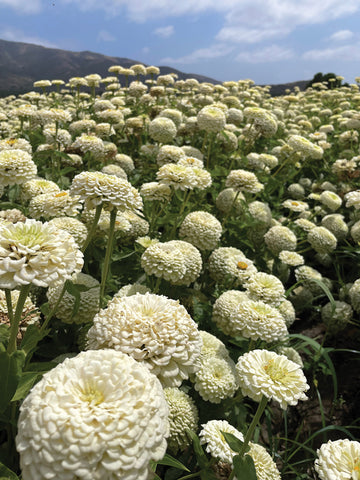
(0, 0), (360, 84)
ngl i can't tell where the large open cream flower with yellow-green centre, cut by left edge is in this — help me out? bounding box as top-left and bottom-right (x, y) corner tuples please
(0, 220), (83, 289)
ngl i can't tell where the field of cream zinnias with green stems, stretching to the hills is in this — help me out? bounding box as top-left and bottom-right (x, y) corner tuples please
(0, 65), (360, 480)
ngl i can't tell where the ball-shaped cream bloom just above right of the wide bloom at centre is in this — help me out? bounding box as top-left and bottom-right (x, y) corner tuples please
(179, 211), (222, 250)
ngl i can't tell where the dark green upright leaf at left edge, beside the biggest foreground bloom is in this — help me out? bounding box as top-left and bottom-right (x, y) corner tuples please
(0, 350), (25, 413)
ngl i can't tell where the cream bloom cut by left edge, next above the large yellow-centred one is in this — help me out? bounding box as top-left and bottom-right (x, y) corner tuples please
(0, 149), (37, 186)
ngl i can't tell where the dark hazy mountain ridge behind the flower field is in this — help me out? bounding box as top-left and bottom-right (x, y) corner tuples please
(0, 40), (308, 96)
